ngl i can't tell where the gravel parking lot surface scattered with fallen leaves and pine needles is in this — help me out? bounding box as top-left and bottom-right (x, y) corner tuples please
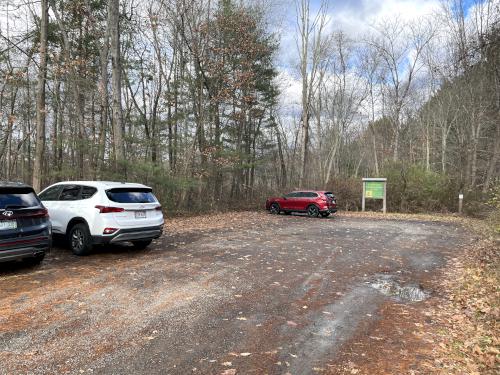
(0, 213), (470, 375)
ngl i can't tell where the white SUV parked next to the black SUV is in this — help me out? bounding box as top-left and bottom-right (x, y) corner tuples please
(39, 181), (164, 255)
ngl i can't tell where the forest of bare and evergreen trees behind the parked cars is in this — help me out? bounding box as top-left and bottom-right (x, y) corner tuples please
(0, 0), (500, 213)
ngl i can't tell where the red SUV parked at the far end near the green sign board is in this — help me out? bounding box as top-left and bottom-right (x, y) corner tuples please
(266, 190), (337, 217)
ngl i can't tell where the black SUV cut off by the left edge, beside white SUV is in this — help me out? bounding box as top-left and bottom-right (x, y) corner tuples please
(0, 181), (52, 264)
